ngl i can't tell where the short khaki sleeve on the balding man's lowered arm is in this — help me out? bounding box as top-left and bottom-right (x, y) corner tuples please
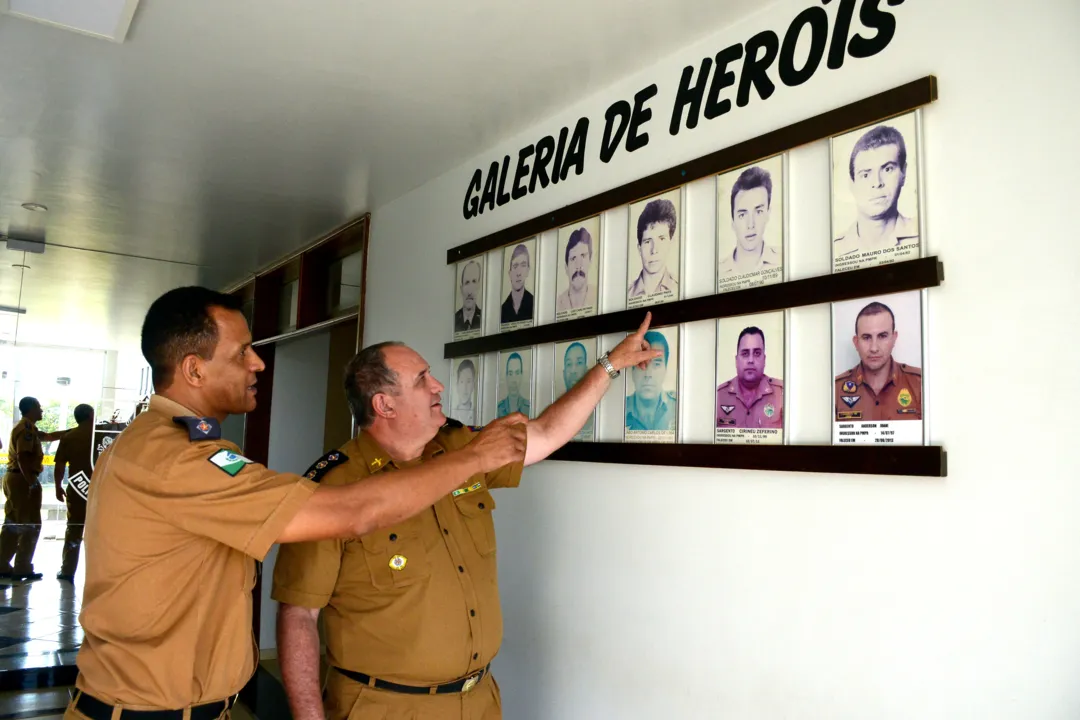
(270, 465), (356, 610)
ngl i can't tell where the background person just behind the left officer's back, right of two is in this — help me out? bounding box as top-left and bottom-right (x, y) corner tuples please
(53, 405), (94, 583)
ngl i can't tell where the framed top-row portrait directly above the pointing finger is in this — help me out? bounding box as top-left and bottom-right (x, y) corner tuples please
(626, 188), (683, 310)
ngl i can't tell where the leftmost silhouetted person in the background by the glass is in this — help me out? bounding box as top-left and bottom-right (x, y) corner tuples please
(0, 397), (67, 581)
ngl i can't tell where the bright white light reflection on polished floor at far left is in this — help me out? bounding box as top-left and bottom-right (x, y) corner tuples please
(0, 533), (83, 677)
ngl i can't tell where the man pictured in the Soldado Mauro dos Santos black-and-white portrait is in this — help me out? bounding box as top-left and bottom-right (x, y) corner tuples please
(833, 125), (919, 259)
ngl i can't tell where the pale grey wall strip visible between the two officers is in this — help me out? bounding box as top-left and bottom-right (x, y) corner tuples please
(259, 332), (330, 650)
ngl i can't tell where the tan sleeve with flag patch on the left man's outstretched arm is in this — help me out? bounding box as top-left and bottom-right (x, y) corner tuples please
(139, 443), (316, 560)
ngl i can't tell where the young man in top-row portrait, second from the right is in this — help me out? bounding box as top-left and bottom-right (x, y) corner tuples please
(718, 165), (782, 280)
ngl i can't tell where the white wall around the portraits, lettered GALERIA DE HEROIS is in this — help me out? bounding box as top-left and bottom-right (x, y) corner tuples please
(360, 0), (1080, 720)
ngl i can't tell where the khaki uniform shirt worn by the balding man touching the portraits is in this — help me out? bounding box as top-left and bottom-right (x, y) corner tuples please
(271, 426), (523, 684)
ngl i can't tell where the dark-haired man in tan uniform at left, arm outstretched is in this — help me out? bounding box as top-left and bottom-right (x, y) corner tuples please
(65, 287), (525, 720)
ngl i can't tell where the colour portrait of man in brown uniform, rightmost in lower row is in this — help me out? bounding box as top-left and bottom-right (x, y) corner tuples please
(833, 290), (923, 445)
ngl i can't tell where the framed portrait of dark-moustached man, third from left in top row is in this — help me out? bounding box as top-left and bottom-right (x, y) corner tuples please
(555, 215), (602, 323)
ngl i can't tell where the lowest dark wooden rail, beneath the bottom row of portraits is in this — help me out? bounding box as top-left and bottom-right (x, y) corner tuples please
(550, 443), (948, 477)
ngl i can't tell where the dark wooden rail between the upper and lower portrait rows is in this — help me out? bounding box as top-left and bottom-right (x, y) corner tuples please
(443, 257), (945, 358)
